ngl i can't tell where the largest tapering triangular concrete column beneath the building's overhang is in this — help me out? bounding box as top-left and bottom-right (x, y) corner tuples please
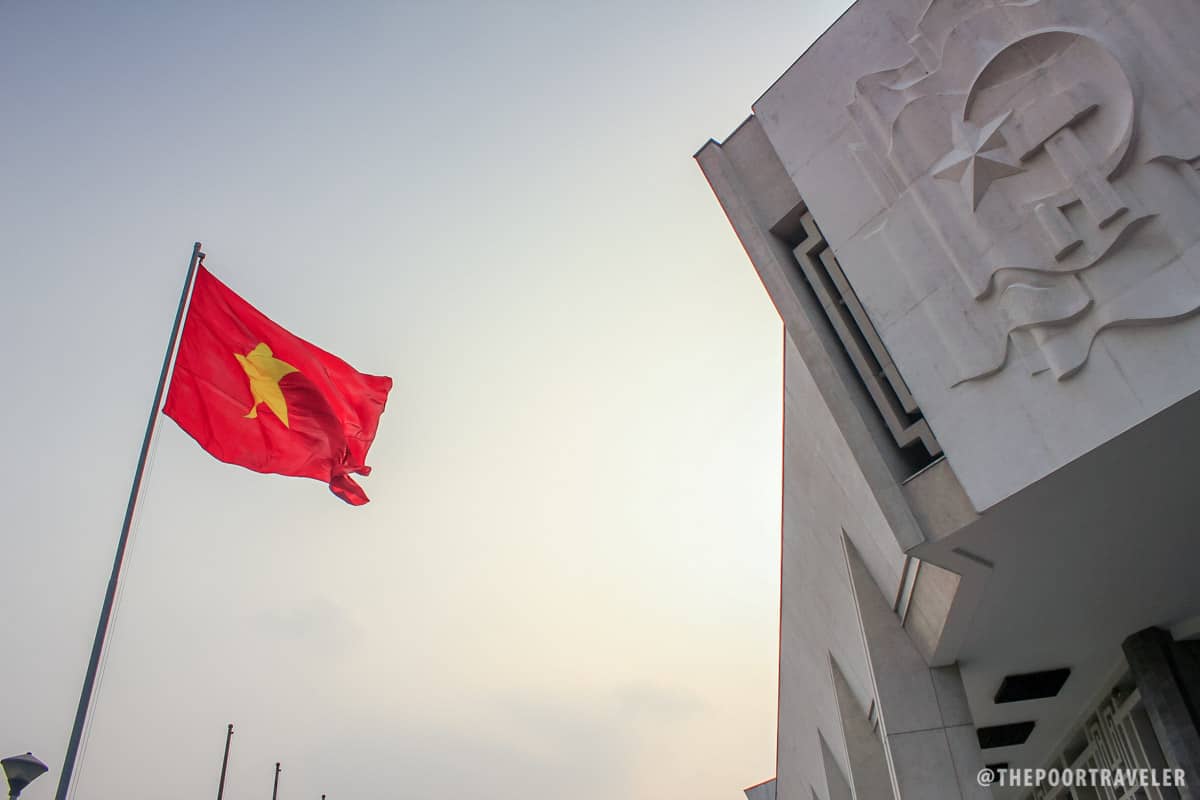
(842, 537), (991, 800)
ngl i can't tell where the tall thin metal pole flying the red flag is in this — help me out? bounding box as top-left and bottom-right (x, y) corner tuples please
(54, 242), (204, 800)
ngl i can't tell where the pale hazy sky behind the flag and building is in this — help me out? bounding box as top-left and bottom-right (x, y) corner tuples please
(0, 0), (847, 800)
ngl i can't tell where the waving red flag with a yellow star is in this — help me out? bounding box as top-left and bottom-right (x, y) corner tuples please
(163, 265), (391, 505)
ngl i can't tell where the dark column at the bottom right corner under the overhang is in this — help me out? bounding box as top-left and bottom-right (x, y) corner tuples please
(1121, 627), (1200, 800)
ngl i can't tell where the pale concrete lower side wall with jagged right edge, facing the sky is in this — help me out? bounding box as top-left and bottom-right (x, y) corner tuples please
(776, 337), (904, 800)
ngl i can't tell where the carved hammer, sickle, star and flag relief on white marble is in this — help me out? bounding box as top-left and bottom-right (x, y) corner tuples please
(848, 0), (1200, 385)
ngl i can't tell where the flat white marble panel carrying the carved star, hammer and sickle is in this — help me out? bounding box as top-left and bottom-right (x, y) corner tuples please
(754, 0), (1200, 511)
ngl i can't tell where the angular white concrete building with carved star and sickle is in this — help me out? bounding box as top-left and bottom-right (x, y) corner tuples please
(696, 0), (1200, 800)
